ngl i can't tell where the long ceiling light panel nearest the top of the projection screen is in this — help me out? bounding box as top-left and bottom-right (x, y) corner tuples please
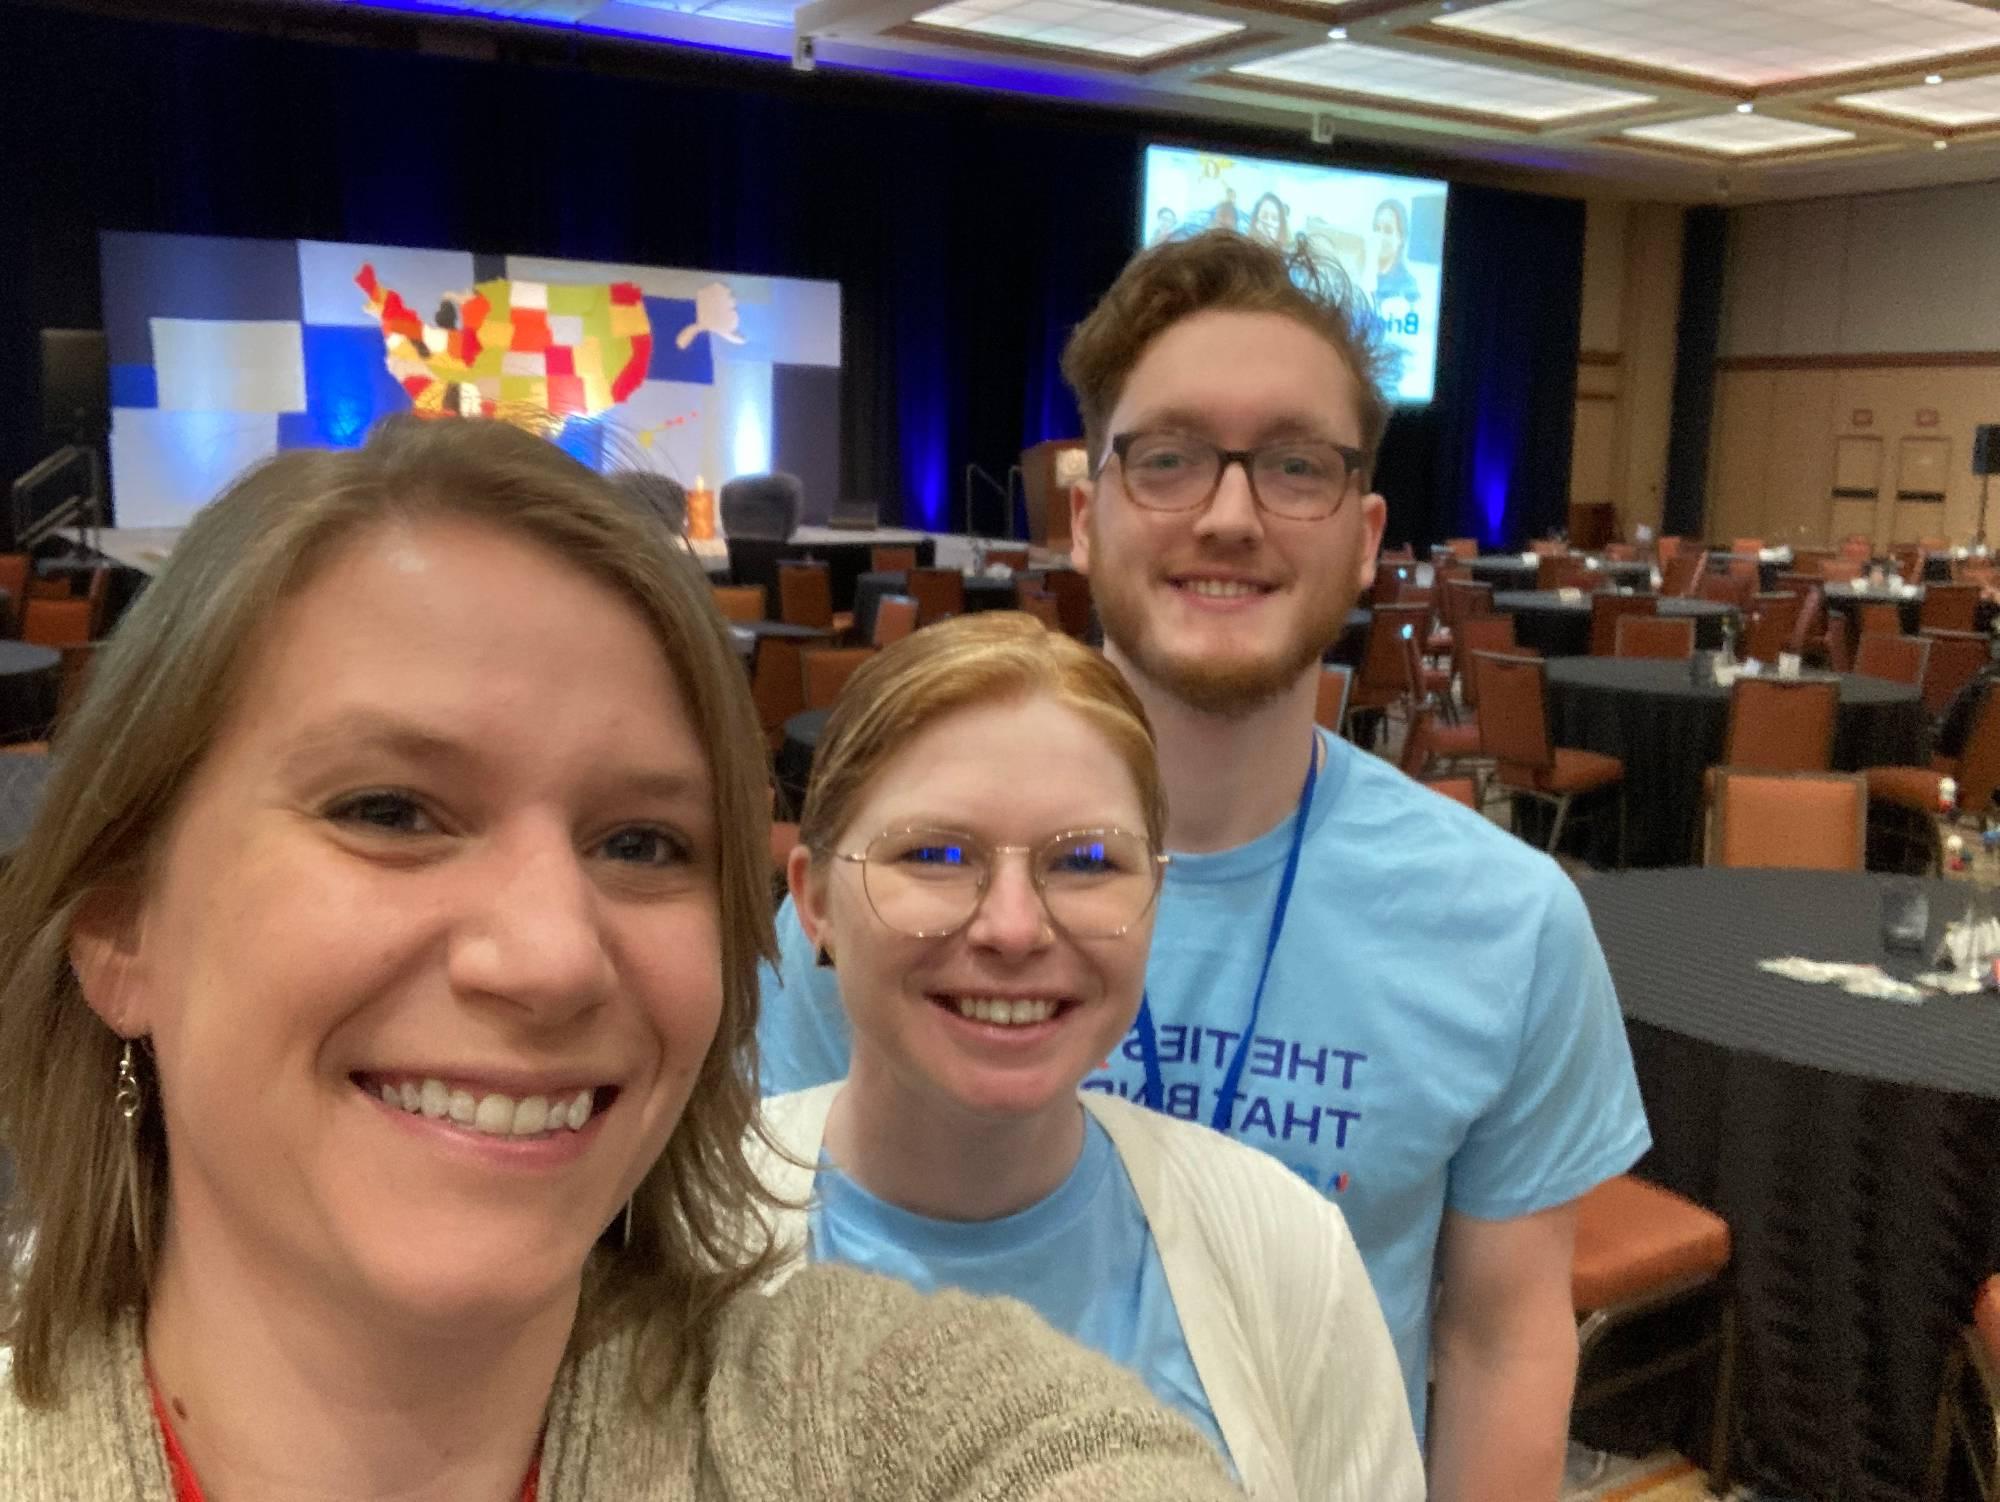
(1230, 42), (1652, 124)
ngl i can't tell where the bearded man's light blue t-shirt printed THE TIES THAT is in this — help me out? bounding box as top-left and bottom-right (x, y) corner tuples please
(758, 736), (1652, 1434)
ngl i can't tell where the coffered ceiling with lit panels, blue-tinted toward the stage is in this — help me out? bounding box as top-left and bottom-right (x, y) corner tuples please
(191, 0), (2000, 200)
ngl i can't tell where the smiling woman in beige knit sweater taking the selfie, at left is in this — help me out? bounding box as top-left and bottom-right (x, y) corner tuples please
(0, 422), (1226, 1502)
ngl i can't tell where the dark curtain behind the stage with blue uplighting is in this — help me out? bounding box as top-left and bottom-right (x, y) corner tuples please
(0, 8), (1582, 542)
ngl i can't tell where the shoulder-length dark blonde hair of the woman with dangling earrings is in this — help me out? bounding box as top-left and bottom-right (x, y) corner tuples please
(0, 418), (774, 1406)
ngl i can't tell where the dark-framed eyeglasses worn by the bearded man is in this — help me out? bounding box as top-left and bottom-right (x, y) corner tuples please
(1112, 432), (1368, 522)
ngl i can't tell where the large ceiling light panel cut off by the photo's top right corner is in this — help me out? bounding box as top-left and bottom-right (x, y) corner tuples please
(1436, 0), (2000, 88)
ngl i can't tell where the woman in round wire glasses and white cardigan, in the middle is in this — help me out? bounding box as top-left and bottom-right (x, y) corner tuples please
(762, 612), (1424, 1502)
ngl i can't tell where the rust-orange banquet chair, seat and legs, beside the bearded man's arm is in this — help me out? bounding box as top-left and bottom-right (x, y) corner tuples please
(1570, 1174), (1736, 1496)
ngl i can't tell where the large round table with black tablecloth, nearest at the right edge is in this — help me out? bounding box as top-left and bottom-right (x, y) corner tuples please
(1578, 868), (2000, 1502)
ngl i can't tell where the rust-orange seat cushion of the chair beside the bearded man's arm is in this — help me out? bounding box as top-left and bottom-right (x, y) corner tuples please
(1570, 1174), (1730, 1314)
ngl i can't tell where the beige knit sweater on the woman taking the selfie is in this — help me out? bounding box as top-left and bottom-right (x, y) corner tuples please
(0, 1268), (1238, 1502)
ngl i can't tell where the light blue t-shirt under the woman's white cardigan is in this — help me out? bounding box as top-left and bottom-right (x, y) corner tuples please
(806, 1112), (1230, 1458)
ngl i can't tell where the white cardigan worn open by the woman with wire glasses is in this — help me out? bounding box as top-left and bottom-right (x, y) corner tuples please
(752, 1080), (1424, 1502)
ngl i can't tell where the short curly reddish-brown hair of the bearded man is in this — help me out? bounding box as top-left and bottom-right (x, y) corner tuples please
(1062, 230), (1396, 480)
